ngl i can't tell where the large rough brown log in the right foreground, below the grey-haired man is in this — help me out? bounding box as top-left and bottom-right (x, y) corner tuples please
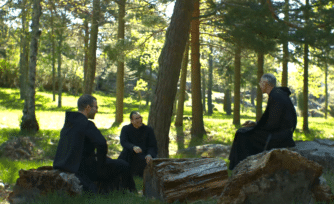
(218, 149), (333, 204)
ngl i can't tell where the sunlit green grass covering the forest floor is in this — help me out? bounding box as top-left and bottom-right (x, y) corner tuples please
(0, 88), (334, 204)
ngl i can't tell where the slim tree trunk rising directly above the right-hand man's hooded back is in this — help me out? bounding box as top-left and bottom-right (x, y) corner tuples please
(282, 0), (289, 87)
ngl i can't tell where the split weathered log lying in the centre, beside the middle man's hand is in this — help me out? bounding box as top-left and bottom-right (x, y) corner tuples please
(143, 158), (228, 203)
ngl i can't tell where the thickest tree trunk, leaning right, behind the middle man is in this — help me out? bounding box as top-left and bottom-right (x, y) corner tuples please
(148, 0), (194, 158)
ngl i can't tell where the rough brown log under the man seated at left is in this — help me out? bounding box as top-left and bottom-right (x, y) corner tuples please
(8, 166), (82, 204)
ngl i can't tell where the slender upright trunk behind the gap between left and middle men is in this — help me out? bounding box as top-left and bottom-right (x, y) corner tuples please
(115, 0), (126, 124)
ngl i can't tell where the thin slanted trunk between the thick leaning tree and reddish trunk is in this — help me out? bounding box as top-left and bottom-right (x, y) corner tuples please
(175, 41), (189, 127)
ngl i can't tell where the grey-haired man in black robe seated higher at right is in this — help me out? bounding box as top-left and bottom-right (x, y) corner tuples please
(229, 74), (297, 170)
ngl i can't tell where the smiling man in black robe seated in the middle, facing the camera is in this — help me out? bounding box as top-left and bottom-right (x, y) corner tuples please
(118, 111), (158, 177)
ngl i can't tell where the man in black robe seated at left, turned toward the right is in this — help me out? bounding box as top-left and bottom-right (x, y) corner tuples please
(53, 94), (136, 193)
